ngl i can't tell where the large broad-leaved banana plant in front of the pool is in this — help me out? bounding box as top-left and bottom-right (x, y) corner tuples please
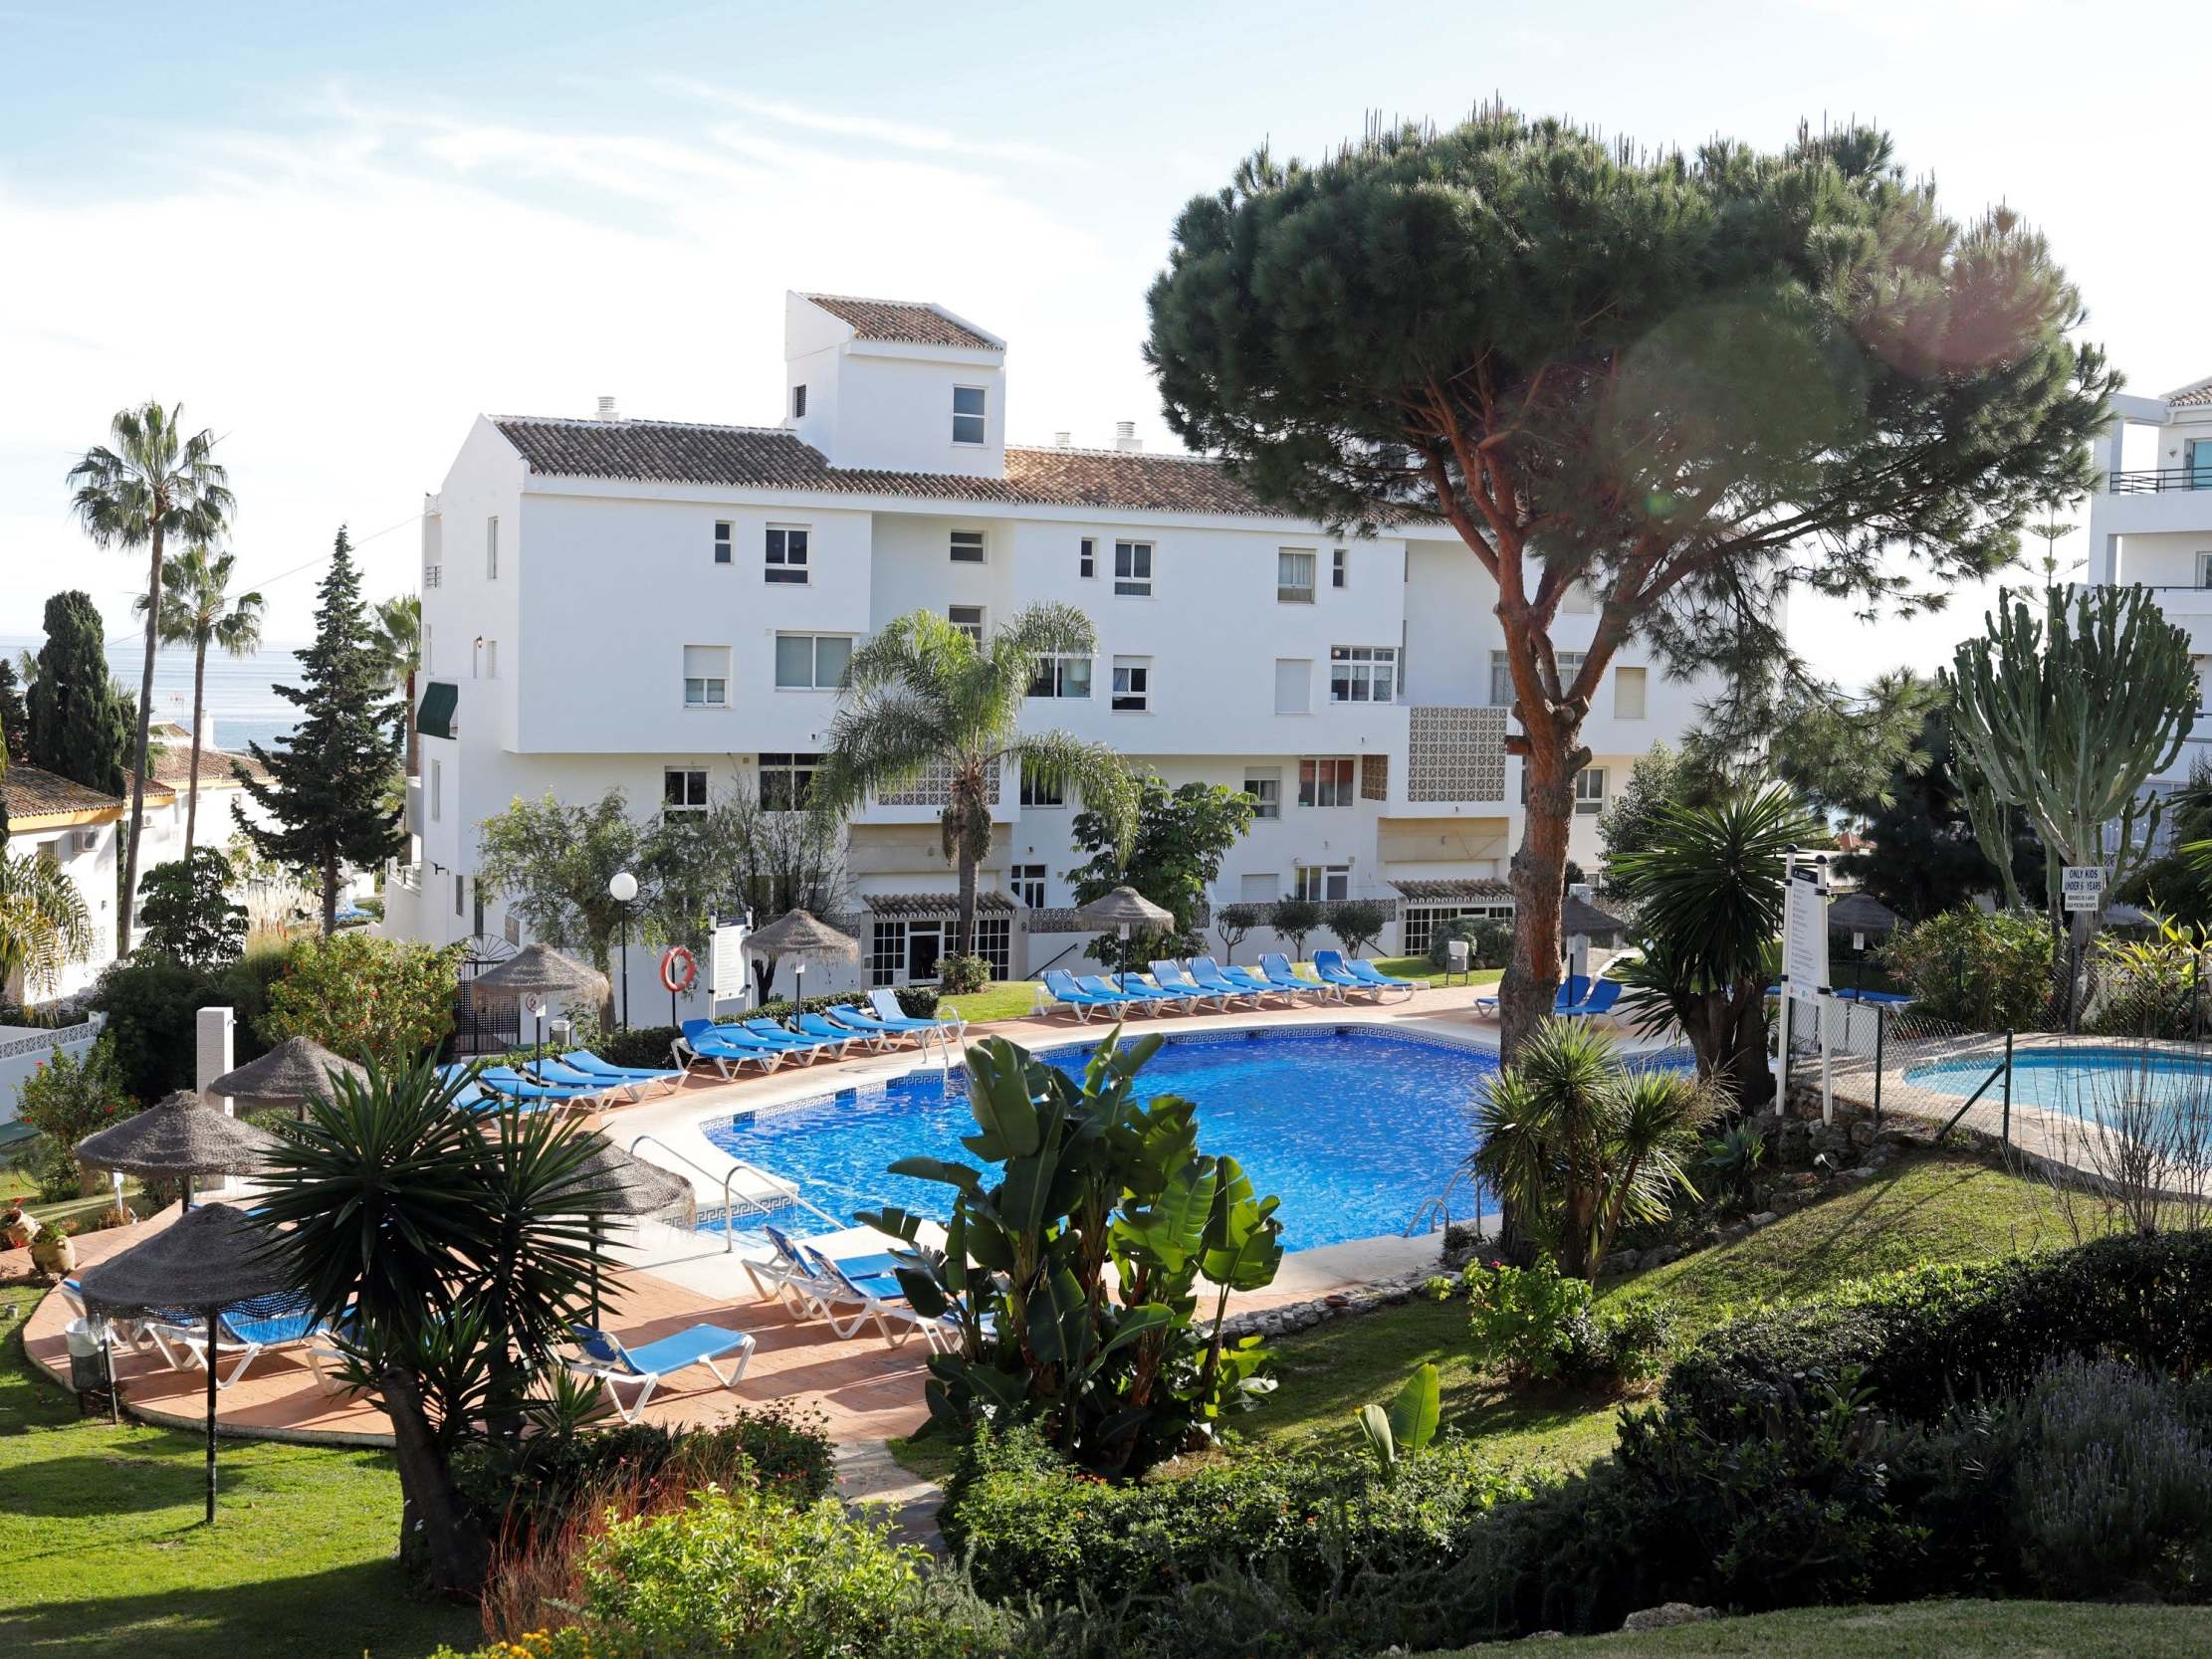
(858, 1031), (1283, 1471)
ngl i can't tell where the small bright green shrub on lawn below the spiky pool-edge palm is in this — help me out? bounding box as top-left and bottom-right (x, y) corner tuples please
(1460, 1261), (1674, 1387)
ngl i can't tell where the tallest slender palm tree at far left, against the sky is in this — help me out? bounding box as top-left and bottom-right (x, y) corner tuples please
(69, 403), (237, 951)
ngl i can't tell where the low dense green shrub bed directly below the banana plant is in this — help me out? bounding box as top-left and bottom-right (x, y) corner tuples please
(940, 1427), (1531, 1610)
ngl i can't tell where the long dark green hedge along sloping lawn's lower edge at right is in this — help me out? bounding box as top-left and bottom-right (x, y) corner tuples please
(1661, 1232), (2212, 1433)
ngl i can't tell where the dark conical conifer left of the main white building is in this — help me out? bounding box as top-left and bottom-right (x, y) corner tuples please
(232, 526), (407, 935)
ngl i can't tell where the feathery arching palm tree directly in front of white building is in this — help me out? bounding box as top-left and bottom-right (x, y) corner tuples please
(814, 604), (1137, 955)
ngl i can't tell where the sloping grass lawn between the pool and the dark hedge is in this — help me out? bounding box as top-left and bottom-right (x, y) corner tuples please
(1241, 1152), (2071, 1467)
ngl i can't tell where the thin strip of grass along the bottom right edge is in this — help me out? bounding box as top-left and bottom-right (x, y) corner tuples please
(1429, 1601), (2212, 1659)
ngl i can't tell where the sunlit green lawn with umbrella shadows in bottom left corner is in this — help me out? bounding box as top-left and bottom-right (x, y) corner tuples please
(0, 1285), (478, 1659)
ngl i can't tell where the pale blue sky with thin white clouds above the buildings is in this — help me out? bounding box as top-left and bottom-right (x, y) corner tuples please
(0, 0), (2212, 686)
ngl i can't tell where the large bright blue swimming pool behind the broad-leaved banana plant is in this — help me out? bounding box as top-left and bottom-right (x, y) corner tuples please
(701, 1026), (1497, 1250)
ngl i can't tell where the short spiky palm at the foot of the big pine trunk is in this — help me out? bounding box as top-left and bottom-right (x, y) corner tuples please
(1468, 1020), (1723, 1279)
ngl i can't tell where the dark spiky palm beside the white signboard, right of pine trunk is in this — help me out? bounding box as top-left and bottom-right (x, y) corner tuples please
(1606, 785), (1814, 1106)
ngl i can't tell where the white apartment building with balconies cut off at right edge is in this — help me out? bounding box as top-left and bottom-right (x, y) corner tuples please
(2089, 378), (2212, 789)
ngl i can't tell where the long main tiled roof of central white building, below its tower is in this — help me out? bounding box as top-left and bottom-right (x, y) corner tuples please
(494, 416), (1287, 518)
